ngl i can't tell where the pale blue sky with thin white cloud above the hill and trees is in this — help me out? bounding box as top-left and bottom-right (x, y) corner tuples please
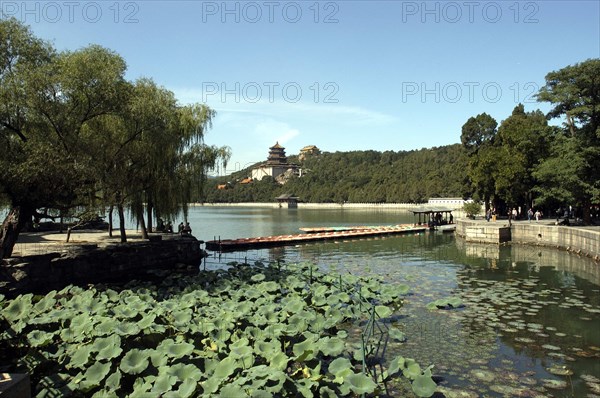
(0, 0), (600, 174)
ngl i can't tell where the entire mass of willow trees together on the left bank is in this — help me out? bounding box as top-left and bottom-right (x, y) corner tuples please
(0, 18), (230, 252)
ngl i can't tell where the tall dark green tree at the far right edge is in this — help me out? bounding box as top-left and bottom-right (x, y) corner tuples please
(535, 58), (600, 221)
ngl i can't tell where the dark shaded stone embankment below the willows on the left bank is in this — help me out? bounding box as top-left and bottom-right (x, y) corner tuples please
(0, 236), (204, 296)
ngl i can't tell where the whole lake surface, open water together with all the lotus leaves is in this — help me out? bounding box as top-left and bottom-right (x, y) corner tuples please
(0, 209), (600, 397)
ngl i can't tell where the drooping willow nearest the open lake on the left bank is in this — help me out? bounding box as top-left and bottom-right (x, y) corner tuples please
(90, 78), (229, 242)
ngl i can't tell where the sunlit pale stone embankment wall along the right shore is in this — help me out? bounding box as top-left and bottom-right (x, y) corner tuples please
(456, 219), (600, 261)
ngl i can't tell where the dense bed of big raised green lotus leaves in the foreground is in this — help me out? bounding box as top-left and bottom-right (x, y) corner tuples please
(0, 264), (435, 397)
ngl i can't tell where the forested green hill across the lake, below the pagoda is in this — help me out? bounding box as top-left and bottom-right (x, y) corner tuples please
(204, 144), (469, 203)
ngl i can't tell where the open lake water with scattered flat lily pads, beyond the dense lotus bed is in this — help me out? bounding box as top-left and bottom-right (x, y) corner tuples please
(189, 207), (600, 397)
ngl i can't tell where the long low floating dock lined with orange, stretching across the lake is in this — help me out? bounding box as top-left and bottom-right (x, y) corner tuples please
(206, 225), (427, 252)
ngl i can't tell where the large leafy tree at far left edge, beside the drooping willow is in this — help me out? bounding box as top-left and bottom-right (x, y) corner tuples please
(0, 19), (125, 258)
